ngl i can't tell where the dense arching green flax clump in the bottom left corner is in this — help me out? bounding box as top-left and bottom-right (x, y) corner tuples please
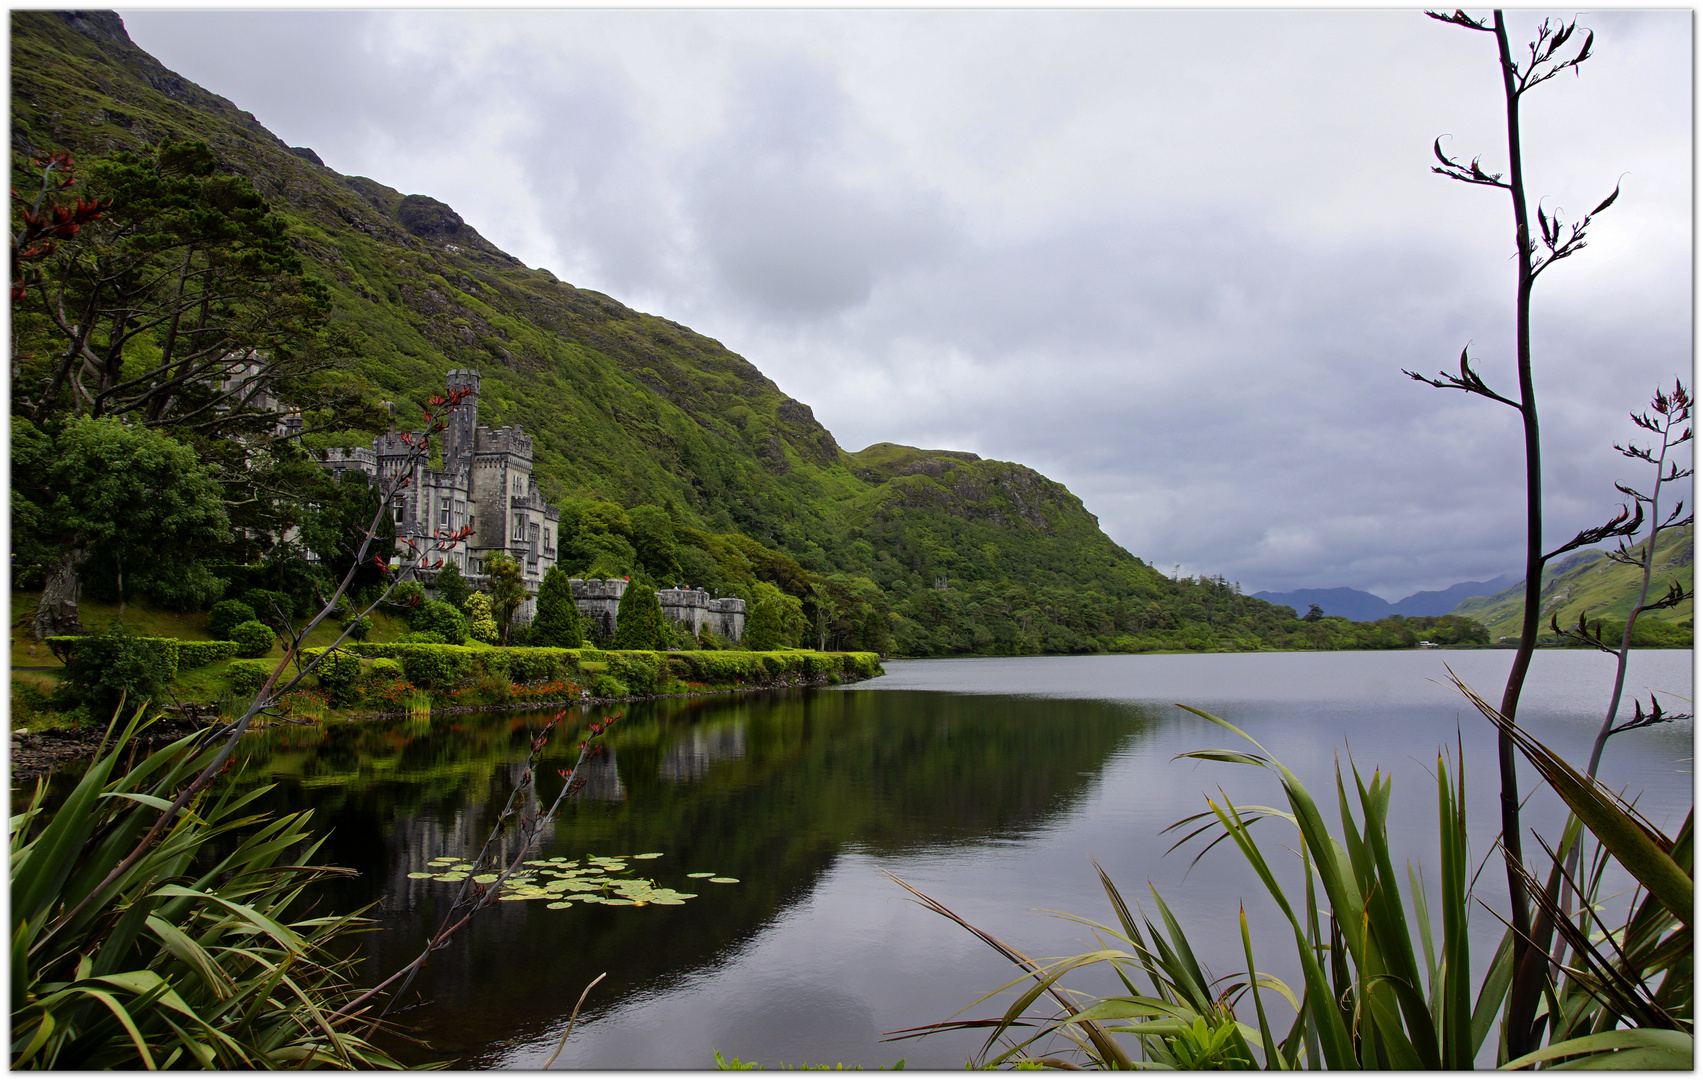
(10, 709), (397, 1070)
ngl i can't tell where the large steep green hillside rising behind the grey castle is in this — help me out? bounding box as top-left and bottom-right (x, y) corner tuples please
(0, 10), (1471, 654)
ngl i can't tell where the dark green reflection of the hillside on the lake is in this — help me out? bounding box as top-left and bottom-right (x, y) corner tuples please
(219, 681), (1153, 1066)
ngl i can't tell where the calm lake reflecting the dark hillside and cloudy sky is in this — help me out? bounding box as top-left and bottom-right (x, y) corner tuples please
(206, 651), (1693, 1070)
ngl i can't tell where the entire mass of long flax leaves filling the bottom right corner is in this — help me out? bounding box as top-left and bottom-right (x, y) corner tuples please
(894, 698), (1693, 1070)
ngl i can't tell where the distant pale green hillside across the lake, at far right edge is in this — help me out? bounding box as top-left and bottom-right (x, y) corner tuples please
(1451, 525), (1693, 641)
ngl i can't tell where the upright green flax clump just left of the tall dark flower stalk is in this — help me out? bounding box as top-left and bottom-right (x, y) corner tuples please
(915, 709), (1511, 1070)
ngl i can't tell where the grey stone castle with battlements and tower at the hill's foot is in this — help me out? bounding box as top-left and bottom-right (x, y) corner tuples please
(320, 368), (744, 642)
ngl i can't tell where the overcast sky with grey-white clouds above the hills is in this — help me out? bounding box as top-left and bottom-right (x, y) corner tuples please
(109, 9), (1693, 600)
